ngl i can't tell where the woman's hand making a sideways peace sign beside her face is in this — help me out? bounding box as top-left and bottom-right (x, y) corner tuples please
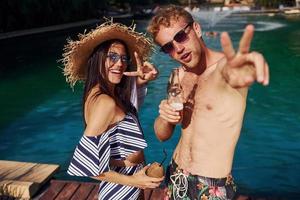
(124, 52), (158, 85)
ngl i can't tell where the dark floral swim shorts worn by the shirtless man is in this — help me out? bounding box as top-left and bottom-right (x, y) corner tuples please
(164, 160), (236, 200)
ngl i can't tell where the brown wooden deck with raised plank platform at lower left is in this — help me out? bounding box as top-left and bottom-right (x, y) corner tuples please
(0, 160), (288, 200)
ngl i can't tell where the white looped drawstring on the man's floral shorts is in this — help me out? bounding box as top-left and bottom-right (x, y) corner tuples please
(170, 171), (188, 199)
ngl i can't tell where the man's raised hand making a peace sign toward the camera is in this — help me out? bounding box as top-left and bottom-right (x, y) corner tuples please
(221, 25), (269, 88)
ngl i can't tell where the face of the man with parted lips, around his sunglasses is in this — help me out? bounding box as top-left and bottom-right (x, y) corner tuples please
(155, 17), (203, 68)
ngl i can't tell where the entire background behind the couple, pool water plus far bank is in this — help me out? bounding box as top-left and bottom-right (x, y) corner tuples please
(0, 0), (300, 199)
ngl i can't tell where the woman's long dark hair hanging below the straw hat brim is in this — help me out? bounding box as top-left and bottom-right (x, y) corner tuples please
(83, 39), (134, 124)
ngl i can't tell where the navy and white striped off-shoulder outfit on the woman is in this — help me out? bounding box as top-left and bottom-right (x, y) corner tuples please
(67, 113), (147, 200)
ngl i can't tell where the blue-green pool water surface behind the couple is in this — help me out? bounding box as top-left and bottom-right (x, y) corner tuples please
(0, 16), (300, 199)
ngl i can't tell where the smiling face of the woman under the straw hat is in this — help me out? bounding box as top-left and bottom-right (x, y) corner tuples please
(105, 42), (128, 84)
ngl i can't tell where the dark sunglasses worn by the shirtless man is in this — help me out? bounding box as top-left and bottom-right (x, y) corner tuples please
(160, 21), (194, 54)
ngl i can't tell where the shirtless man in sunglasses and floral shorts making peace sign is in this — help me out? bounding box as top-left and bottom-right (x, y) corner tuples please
(148, 6), (269, 199)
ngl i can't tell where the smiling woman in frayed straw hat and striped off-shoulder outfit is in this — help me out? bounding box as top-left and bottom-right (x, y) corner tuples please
(63, 23), (162, 200)
